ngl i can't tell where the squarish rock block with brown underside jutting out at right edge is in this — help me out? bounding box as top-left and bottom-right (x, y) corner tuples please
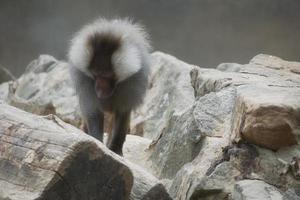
(235, 86), (300, 150)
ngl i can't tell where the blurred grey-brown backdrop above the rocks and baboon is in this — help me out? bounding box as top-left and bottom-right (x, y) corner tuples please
(0, 0), (300, 76)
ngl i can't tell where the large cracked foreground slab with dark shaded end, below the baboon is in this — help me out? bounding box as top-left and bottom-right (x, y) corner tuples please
(0, 103), (170, 200)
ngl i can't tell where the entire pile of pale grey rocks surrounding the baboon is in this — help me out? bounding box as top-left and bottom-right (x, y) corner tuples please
(0, 52), (300, 200)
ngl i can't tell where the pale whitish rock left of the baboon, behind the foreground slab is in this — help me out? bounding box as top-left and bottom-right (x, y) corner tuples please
(0, 55), (82, 127)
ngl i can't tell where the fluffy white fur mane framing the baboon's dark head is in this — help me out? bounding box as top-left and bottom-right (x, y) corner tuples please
(68, 18), (150, 81)
